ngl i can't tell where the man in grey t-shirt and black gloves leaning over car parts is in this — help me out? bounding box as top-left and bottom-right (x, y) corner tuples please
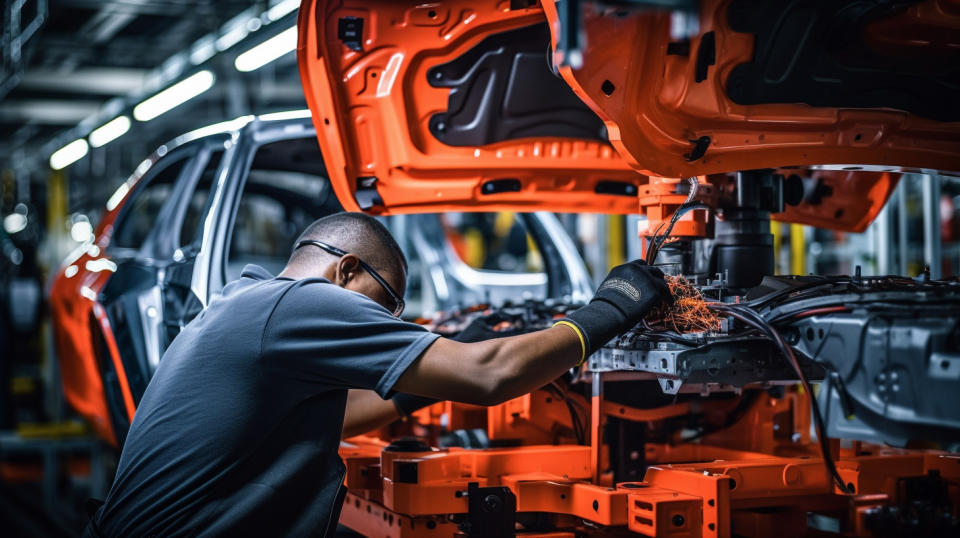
(85, 213), (669, 537)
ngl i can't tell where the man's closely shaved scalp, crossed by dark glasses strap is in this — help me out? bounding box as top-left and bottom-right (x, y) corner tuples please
(287, 213), (407, 279)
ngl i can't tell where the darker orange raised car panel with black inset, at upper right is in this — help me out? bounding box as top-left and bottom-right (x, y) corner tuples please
(543, 0), (960, 177)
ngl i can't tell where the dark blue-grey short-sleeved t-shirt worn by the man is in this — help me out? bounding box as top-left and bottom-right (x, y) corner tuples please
(94, 266), (438, 536)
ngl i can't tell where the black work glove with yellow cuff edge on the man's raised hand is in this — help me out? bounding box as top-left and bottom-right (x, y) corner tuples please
(558, 261), (673, 358)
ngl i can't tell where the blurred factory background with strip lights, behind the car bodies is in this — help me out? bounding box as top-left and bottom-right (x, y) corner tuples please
(0, 0), (960, 536)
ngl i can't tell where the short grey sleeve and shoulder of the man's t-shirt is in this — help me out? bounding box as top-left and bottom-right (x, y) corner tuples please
(260, 281), (439, 399)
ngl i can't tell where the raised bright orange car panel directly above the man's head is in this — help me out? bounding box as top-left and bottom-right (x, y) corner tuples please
(297, 0), (646, 214)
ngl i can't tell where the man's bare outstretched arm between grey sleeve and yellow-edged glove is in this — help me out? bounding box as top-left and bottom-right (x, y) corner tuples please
(394, 326), (584, 405)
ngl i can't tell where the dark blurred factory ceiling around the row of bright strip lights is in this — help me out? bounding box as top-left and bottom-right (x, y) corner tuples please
(0, 0), (303, 182)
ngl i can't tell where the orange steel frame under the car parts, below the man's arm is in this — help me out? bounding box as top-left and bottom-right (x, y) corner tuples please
(340, 374), (960, 537)
